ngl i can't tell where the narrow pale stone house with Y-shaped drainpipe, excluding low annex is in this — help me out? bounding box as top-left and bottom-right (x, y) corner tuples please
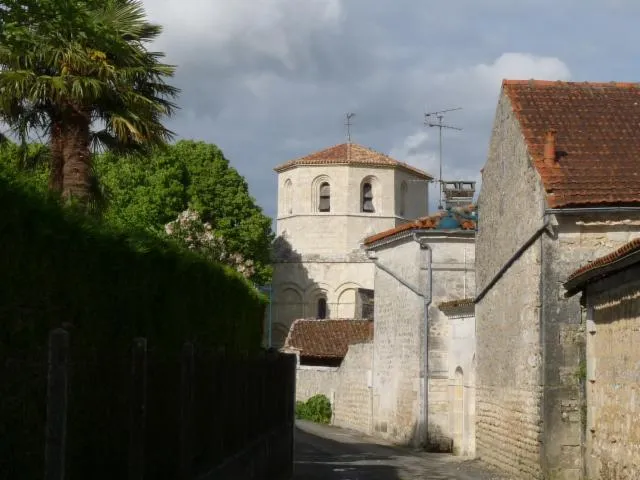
(364, 184), (476, 453)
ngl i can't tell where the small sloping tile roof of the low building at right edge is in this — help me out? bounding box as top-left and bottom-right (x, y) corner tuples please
(564, 238), (640, 296)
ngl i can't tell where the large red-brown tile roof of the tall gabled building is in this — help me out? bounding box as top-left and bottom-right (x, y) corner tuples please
(502, 80), (640, 208)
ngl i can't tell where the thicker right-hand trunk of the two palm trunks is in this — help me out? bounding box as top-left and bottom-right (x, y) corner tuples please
(62, 108), (91, 205)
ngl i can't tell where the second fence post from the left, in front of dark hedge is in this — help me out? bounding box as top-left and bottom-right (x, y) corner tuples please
(129, 338), (147, 480)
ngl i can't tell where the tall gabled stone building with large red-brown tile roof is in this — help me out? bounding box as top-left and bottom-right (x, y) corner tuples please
(475, 80), (640, 479)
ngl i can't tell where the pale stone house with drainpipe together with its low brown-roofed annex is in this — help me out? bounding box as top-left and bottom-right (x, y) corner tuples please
(284, 182), (476, 455)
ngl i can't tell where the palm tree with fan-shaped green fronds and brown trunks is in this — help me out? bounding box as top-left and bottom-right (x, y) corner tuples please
(0, 0), (178, 204)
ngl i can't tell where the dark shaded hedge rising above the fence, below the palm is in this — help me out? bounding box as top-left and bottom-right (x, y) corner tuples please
(0, 171), (264, 351)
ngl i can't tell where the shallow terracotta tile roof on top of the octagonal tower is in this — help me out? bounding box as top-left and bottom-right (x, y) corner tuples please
(274, 143), (433, 180)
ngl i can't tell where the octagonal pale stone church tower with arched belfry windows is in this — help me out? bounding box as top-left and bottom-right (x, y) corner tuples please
(272, 143), (432, 347)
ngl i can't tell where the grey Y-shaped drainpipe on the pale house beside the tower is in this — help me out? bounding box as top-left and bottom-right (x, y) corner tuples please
(366, 233), (433, 446)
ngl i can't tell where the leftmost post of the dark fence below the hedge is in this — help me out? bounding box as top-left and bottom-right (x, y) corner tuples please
(44, 328), (69, 480)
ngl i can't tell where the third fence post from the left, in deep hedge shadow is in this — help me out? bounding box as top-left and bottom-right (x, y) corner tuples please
(180, 342), (194, 480)
